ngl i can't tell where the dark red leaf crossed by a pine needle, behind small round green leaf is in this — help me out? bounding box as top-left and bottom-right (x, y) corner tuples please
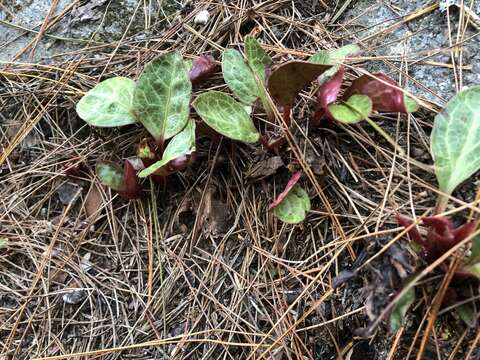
(344, 73), (408, 113)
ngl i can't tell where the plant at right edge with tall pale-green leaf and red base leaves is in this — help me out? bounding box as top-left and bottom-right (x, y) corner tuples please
(390, 86), (480, 330)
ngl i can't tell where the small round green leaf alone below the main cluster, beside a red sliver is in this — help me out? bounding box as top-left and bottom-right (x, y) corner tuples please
(273, 185), (311, 224)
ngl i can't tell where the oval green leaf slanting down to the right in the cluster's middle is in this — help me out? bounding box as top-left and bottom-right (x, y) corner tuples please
(193, 91), (260, 143)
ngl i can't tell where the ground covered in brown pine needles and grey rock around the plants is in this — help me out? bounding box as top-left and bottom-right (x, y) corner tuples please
(0, 0), (480, 360)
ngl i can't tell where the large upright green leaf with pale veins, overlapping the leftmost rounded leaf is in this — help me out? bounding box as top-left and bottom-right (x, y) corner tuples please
(133, 52), (192, 141)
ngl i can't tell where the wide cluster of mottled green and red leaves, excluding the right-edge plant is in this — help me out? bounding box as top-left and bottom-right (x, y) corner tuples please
(76, 40), (417, 224)
